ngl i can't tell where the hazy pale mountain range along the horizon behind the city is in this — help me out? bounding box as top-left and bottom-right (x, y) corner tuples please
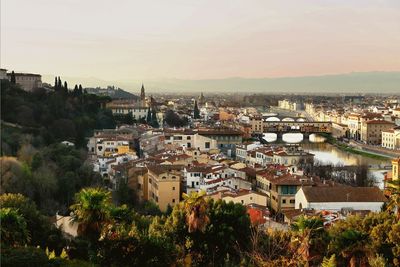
(43, 71), (400, 94)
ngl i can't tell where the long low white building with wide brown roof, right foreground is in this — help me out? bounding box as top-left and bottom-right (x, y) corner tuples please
(295, 186), (386, 212)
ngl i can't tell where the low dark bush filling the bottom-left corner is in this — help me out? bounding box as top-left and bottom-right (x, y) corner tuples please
(1, 247), (49, 267)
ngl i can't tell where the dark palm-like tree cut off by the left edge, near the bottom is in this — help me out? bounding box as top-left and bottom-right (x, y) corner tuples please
(0, 208), (29, 247)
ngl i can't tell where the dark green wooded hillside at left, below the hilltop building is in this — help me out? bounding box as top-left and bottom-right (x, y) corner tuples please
(1, 78), (115, 151)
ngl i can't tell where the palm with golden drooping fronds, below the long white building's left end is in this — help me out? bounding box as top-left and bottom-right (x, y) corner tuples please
(291, 216), (326, 266)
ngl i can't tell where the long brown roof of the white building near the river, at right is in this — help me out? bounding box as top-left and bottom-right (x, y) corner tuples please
(302, 186), (387, 202)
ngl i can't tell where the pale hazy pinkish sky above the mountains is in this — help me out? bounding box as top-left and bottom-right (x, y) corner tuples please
(1, 0), (400, 81)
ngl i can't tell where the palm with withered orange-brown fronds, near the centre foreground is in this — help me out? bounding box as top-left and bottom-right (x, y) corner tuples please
(183, 191), (210, 233)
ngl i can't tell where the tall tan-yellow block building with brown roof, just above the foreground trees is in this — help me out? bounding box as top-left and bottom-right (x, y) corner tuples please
(147, 165), (182, 211)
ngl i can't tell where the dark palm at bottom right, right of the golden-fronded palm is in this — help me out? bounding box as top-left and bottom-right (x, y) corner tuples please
(331, 229), (370, 267)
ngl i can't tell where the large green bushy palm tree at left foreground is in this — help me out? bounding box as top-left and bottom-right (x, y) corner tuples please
(71, 188), (111, 241)
